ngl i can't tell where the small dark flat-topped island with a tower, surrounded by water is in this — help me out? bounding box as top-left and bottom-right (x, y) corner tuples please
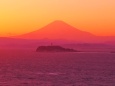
(36, 45), (77, 52)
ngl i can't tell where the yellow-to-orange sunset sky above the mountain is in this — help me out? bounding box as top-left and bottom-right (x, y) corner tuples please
(0, 0), (115, 36)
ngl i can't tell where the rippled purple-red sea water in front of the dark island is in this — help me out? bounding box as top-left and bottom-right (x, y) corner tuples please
(0, 50), (115, 86)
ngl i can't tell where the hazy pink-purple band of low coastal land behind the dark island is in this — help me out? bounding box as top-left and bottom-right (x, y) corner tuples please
(0, 37), (115, 52)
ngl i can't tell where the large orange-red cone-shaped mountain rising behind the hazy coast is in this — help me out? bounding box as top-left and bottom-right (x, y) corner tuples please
(17, 20), (95, 42)
